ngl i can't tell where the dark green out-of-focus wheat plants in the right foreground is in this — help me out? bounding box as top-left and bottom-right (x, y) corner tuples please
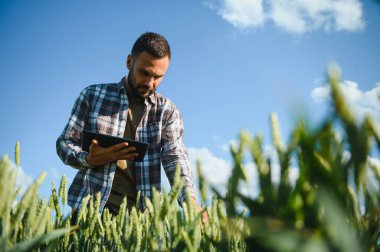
(214, 66), (380, 251)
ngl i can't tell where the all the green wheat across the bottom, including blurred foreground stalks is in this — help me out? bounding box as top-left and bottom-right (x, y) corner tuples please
(0, 66), (380, 251)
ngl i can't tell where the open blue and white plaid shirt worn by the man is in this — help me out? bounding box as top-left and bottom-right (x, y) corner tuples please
(56, 79), (196, 211)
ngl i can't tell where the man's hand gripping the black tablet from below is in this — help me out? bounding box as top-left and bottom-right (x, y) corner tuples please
(86, 139), (138, 167)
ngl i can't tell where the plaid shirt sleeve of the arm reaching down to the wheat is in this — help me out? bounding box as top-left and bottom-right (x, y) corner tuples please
(161, 107), (197, 204)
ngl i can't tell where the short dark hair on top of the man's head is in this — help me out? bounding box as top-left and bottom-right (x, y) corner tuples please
(132, 32), (171, 59)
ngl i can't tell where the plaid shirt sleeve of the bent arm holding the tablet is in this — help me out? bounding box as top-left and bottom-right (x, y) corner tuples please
(56, 88), (93, 169)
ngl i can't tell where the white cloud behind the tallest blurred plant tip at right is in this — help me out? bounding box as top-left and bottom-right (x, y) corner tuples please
(311, 81), (380, 123)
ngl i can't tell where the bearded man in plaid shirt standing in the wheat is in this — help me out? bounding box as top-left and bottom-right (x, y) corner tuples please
(57, 32), (206, 222)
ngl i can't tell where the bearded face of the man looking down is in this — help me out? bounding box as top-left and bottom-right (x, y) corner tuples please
(127, 52), (169, 98)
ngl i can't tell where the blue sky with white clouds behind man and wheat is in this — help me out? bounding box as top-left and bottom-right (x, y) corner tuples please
(0, 0), (380, 203)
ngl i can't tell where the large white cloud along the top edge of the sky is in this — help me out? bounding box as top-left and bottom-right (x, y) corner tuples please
(205, 0), (365, 34)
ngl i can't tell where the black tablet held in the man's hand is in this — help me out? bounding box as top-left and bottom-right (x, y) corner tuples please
(82, 130), (148, 162)
